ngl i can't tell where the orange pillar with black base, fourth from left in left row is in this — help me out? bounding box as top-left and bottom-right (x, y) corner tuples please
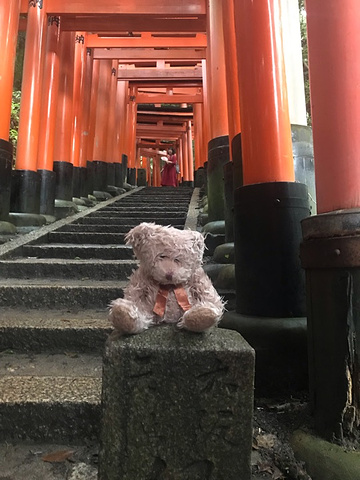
(54, 32), (75, 201)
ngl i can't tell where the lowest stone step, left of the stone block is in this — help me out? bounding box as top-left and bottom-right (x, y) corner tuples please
(0, 356), (102, 444)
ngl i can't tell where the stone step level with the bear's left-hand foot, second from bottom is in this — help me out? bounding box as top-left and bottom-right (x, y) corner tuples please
(0, 306), (113, 354)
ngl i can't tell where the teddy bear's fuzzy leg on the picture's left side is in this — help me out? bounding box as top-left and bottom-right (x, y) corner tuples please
(109, 298), (152, 334)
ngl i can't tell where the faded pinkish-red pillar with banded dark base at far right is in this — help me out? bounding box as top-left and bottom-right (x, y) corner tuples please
(301, 0), (360, 442)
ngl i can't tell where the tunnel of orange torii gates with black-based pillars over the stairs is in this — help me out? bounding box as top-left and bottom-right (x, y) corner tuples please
(0, 0), (360, 438)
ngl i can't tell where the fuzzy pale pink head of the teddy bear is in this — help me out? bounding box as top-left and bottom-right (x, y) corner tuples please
(125, 222), (205, 285)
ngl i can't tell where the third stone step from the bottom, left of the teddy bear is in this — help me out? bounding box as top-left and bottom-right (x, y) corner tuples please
(0, 278), (127, 309)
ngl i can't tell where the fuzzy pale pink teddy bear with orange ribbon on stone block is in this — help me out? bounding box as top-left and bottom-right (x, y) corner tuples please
(109, 222), (225, 335)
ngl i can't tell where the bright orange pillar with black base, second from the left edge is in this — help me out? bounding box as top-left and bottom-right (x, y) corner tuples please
(10, 1), (46, 214)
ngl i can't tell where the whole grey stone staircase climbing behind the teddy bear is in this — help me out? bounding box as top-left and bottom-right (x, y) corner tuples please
(0, 187), (197, 444)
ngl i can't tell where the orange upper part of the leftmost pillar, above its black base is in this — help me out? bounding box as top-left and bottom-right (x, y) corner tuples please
(0, 0), (20, 141)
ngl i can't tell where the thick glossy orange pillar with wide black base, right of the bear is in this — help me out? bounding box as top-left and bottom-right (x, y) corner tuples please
(222, 0), (309, 392)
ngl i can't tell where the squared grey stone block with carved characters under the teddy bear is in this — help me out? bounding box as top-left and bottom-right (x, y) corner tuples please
(99, 325), (254, 480)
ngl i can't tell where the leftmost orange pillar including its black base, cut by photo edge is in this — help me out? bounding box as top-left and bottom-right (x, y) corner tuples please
(0, 0), (20, 228)
